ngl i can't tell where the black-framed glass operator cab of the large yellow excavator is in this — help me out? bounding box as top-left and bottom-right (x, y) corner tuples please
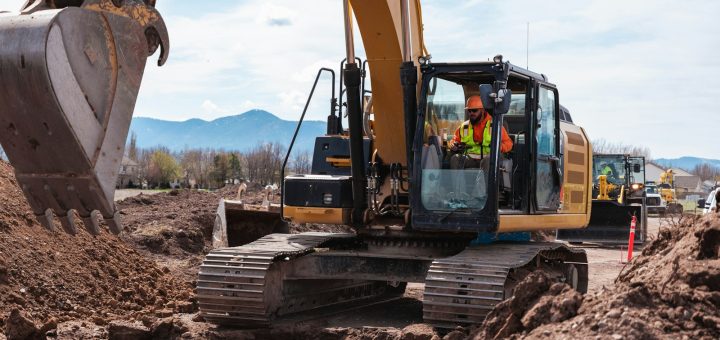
(413, 63), (562, 231)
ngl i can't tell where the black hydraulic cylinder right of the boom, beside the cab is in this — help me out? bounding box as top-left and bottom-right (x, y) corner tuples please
(400, 61), (417, 179)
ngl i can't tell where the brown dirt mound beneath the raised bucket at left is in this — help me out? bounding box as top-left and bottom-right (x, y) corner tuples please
(0, 162), (194, 333)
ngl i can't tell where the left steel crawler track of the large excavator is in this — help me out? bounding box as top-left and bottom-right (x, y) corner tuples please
(197, 233), (396, 327)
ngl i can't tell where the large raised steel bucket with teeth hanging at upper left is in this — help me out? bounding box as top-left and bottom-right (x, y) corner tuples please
(0, 0), (169, 234)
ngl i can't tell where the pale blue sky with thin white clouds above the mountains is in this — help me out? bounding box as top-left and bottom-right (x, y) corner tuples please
(0, 0), (720, 159)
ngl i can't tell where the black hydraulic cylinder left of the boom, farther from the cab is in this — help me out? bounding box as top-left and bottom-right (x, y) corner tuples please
(344, 63), (367, 226)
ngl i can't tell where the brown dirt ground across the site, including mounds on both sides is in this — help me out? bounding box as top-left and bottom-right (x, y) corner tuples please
(0, 162), (720, 339)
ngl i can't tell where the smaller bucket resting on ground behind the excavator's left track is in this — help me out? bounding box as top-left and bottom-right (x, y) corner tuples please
(213, 198), (288, 248)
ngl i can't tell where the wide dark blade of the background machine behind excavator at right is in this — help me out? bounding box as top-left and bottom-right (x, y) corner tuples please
(557, 200), (647, 245)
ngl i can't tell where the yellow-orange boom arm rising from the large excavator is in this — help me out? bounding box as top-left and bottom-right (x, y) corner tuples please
(350, 0), (424, 165)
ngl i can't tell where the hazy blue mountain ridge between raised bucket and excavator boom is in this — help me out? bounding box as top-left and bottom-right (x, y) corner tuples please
(128, 110), (326, 151)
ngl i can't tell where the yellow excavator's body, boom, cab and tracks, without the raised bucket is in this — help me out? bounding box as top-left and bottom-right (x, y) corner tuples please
(197, 0), (593, 328)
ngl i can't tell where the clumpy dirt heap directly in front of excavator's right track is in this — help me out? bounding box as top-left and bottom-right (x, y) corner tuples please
(471, 271), (582, 339)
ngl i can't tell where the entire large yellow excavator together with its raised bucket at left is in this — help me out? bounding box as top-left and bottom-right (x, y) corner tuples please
(0, 0), (592, 328)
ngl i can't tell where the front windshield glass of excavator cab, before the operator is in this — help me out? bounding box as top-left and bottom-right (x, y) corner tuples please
(421, 77), (489, 211)
